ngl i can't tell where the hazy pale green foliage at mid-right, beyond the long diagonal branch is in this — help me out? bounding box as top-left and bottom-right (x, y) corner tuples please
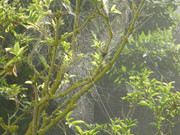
(110, 28), (180, 87)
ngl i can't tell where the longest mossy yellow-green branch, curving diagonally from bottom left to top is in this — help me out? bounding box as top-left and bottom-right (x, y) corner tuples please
(34, 0), (145, 135)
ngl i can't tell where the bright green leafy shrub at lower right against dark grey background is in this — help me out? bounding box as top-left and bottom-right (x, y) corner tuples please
(123, 70), (180, 135)
